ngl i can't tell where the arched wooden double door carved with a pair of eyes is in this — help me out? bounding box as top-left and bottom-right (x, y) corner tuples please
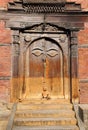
(26, 38), (64, 98)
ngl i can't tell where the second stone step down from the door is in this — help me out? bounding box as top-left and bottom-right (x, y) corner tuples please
(15, 110), (75, 118)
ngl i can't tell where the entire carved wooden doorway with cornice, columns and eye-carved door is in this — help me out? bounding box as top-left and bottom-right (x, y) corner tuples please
(5, 0), (86, 103)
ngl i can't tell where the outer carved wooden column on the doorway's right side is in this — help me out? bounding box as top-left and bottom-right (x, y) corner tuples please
(70, 31), (79, 103)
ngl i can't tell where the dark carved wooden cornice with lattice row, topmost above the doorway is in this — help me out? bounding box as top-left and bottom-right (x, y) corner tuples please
(8, 0), (81, 13)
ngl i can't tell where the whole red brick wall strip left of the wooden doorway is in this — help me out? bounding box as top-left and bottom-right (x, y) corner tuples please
(0, 21), (11, 101)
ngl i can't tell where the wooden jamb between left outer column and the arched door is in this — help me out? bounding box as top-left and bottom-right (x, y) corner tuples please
(19, 33), (29, 101)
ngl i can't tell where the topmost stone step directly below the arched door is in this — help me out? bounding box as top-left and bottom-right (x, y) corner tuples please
(17, 103), (73, 110)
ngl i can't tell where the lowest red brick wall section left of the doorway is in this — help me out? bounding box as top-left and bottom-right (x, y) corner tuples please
(0, 80), (10, 102)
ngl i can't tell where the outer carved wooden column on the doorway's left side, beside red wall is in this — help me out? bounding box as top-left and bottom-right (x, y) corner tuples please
(11, 31), (20, 101)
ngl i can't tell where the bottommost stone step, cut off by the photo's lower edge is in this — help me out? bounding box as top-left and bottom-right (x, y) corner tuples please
(12, 125), (79, 130)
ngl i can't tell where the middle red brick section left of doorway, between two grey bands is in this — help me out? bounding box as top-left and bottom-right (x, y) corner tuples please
(0, 46), (11, 76)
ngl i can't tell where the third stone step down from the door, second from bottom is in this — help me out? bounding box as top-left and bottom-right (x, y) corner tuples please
(14, 118), (77, 126)
